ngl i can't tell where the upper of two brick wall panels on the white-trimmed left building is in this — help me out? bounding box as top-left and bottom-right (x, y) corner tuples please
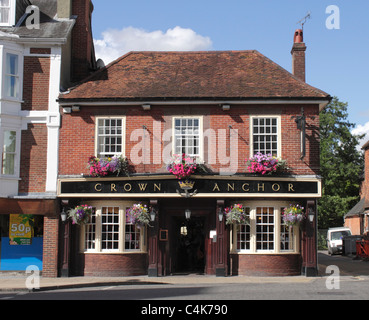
(22, 57), (50, 110)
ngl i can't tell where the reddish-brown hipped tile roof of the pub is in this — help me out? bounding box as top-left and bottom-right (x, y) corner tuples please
(60, 50), (329, 101)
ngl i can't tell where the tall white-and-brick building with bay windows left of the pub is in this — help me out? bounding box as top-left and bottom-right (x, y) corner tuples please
(0, 0), (96, 277)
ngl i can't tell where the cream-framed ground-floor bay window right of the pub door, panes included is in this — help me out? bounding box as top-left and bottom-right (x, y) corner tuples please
(231, 201), (299, 253)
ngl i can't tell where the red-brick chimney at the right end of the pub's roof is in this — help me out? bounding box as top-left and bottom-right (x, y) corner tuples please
(291, 29), (306, 82)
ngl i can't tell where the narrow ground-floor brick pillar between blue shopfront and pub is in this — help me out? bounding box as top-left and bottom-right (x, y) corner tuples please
(42, 216), (60, 278)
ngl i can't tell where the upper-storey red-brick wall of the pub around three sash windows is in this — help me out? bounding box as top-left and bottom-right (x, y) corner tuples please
(59, 105), (320, 175)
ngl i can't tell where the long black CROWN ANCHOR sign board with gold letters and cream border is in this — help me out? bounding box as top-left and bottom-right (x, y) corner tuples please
(58, 176), (321, 198)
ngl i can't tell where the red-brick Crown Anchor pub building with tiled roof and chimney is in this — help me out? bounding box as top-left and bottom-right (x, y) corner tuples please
(58, 30), (331, 276)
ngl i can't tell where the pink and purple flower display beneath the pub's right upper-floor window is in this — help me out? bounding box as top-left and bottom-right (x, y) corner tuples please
(246, 152), (287, 175)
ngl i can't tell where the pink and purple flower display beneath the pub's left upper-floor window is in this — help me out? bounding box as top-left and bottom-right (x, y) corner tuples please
(88, 156), (129, 177)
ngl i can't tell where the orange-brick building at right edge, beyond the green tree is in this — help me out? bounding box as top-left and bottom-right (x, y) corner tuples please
(344, 141), (369, 235)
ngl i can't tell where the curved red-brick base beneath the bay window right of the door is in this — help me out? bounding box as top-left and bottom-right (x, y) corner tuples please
(230, 254), (301, 277)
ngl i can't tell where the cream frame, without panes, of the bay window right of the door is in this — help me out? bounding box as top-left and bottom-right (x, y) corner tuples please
(230, 201), (300, 254)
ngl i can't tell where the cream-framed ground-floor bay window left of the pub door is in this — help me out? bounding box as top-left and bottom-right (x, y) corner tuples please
(81, 201), (146, 253)
